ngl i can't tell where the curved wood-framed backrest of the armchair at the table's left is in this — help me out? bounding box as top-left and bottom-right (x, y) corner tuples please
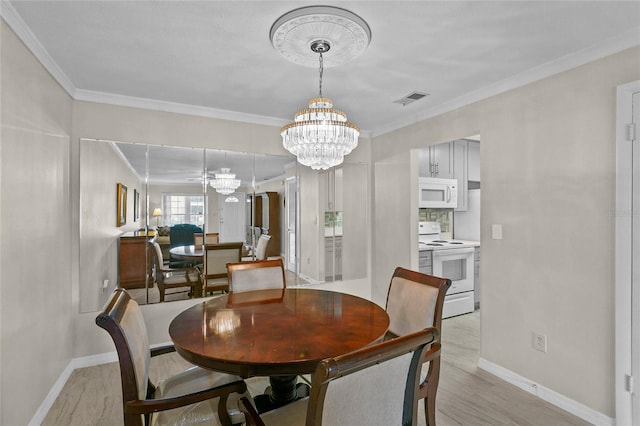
(96, 288), (151, 425)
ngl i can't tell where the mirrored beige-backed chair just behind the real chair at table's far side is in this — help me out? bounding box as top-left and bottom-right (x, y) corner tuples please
(200, 242), (242, 295)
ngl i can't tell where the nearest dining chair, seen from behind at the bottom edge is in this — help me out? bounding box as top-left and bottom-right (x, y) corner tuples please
(240, 327), (439, 426)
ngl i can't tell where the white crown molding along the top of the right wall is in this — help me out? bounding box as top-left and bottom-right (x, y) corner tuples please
(371, 26), (640, 137)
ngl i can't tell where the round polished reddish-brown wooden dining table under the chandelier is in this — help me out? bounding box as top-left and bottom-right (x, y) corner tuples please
(169, 288), (389, 412)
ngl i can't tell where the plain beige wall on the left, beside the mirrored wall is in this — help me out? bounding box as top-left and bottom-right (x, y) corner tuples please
(0, 21), (73, 425)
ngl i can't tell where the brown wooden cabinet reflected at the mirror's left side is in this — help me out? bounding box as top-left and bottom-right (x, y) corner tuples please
(118, 232), (153, 289)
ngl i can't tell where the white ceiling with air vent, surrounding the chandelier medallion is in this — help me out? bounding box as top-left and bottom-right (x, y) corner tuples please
(3, 1), (640, 135)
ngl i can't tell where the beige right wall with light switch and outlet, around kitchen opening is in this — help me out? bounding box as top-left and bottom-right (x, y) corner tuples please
(372, 47), (640, 417)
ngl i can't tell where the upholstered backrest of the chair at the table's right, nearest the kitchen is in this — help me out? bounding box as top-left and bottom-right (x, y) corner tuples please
(386, 267), (451, 336)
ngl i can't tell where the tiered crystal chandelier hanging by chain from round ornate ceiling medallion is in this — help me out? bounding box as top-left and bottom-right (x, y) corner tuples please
(270, 6), (371, 170)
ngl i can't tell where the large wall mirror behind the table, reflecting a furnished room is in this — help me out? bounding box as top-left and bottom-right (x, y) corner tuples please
(79, 139), (368, 312)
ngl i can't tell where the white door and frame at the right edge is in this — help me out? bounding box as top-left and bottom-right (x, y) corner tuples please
(612, 81), (640, 425)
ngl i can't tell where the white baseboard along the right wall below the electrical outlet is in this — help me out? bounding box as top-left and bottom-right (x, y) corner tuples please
(478, 358), (615, 426)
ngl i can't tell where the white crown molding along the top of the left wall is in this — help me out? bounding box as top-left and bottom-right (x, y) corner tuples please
(0, 0), (76, 98)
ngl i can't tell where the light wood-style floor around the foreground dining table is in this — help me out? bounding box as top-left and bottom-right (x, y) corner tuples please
(42, 311), (588, 426)
